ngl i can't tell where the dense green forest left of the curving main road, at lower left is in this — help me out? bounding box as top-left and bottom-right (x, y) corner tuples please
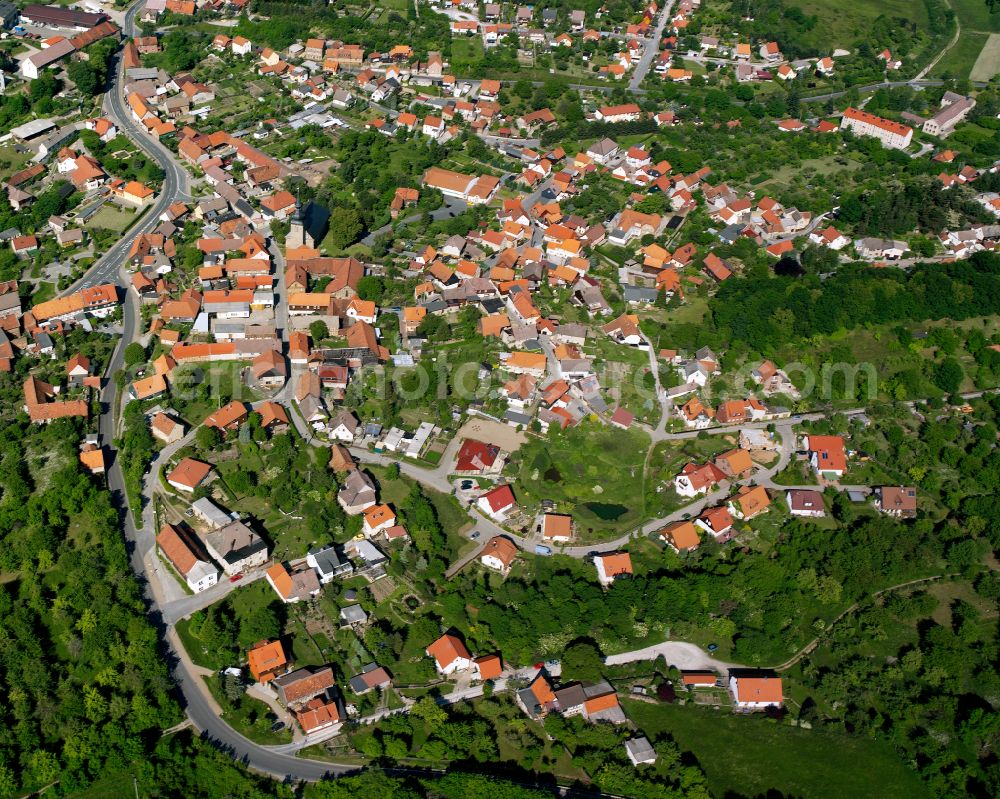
(0, 420), (181, 795)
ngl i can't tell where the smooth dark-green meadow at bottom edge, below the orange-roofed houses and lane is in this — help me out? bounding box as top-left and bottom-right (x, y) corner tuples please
(622, 699), (927, 799)
